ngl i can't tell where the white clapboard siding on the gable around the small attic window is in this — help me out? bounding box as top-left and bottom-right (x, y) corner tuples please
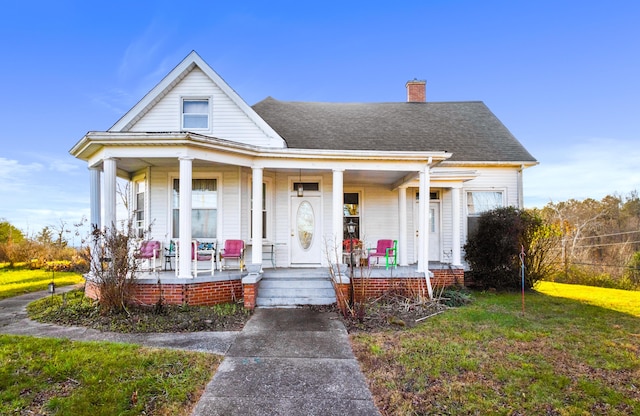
(131, 68), (276, 146)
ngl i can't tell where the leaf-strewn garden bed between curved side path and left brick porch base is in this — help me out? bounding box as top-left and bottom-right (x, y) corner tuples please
(27, 290), (251, 333)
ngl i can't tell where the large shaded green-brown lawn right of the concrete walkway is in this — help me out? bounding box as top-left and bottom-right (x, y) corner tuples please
(351, 288), (640, 415)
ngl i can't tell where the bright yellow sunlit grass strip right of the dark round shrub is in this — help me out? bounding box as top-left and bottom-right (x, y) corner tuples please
(535, 281), (640, 317)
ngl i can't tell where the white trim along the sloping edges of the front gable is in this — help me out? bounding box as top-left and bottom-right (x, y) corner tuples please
(109, 51), (282, 145)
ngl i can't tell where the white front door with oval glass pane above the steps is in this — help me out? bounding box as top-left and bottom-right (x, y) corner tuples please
(290, 196), (322, 266)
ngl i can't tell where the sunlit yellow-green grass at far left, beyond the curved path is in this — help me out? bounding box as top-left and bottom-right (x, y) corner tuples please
(0, 268), (84, 299)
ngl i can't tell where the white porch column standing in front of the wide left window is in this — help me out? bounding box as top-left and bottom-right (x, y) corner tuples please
(178, 156), (193, 278)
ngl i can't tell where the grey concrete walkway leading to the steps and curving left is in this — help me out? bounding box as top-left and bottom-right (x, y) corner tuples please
(0, 288), (380, 416)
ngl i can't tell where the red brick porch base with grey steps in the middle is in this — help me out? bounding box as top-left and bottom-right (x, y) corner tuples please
(91, 263), (464, 309)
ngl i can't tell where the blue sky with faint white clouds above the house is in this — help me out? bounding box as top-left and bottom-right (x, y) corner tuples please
(0, 0), (640, 239)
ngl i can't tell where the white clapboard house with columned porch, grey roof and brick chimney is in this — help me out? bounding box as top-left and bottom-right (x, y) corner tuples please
(70, 52), (537, 307)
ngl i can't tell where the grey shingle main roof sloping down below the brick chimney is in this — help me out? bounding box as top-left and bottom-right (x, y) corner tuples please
(253, 97), (535, 162)
